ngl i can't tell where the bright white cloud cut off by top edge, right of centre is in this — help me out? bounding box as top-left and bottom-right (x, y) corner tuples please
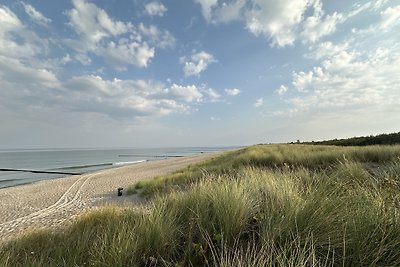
(246, 0), (345, 47)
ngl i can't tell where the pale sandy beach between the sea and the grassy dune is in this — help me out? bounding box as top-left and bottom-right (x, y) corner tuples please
(0, 153), (218, 243)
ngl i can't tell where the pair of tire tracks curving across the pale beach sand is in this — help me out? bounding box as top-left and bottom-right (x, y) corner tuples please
(0, 174), (95, 233)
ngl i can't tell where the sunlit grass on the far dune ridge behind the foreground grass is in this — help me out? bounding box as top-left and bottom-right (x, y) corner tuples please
(128, 145), (400, 197)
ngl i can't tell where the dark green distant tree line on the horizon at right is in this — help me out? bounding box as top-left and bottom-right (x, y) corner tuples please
(303, 132), (400, 146)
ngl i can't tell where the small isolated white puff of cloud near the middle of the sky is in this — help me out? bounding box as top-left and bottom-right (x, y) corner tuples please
(180, 51), (217, 76)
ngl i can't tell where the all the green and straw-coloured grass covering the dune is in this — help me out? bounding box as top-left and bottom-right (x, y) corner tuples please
(0, 145), (400, 266)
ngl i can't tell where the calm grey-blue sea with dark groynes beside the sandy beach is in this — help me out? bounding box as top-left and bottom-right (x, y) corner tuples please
(0, 147), (236, 189)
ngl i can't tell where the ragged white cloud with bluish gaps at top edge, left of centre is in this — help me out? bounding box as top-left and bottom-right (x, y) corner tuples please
(65, 0), (175, 70)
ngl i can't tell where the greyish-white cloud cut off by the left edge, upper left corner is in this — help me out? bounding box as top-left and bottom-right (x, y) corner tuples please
(0, 5), (60, 101)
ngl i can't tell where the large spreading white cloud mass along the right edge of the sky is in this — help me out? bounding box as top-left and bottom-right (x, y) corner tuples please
(275, 1), (400, 119)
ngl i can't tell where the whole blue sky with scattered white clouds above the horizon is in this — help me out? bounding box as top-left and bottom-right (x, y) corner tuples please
(0, 0), (400, 149)
